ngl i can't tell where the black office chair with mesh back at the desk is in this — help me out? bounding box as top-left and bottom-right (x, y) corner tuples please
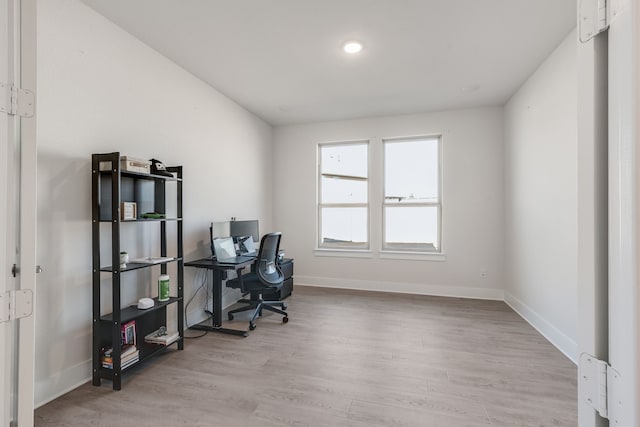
(227, 233), (289, 330)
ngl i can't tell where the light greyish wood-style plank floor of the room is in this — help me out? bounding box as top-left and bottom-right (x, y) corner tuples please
(35, 286), (577, 427)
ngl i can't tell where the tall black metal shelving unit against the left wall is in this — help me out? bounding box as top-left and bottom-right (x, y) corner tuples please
(91, 152), (184, 390)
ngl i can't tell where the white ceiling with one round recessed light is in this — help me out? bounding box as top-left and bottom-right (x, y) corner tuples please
(83, 0), (576, 125)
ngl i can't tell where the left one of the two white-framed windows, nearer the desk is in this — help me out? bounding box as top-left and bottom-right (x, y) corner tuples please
(318, 141), (369, 249)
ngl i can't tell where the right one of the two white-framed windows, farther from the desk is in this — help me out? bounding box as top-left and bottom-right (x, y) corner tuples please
(382, 137), (442, 252)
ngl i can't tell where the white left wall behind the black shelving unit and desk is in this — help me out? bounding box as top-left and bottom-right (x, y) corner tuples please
(36, 0), (272, 405)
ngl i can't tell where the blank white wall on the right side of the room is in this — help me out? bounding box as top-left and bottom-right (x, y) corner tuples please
(504, 31), (578, 361)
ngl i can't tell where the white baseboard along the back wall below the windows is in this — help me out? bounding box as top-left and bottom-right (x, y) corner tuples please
(294, 275), (504, 301)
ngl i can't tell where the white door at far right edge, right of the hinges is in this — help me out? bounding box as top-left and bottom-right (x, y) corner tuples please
(608, 0), (640, 426)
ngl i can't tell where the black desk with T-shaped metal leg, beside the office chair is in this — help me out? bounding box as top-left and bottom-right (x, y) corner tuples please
(184, 258), (255, 337)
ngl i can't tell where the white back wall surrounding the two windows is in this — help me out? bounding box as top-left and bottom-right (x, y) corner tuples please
(274, 107), (504, 299)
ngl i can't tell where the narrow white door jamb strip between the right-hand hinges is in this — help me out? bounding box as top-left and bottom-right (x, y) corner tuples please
(577, 17), (609, 427)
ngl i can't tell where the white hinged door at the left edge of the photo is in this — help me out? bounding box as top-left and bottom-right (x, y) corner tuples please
(0, 0), (36, 427)
